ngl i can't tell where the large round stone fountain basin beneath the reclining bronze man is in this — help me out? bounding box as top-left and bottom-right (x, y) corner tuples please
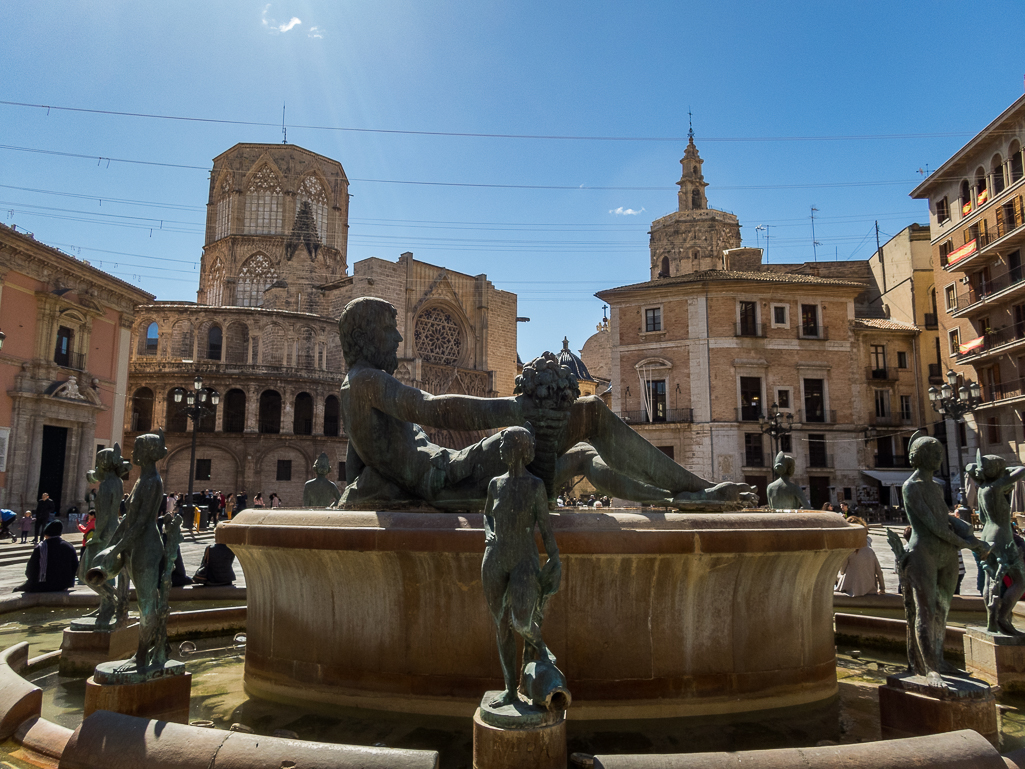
(217, 509), (865, 720)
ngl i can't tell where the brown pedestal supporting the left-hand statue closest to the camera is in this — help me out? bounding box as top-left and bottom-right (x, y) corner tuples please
(85, 660), (192, 724)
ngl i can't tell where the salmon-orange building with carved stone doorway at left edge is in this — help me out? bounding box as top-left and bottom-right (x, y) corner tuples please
(0, 225), (153, 512)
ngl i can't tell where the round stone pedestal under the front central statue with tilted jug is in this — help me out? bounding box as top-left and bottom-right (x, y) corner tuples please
(474, 691), (566, 769)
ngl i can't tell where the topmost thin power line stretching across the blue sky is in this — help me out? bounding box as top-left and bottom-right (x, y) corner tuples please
(0, 100), (979, 143)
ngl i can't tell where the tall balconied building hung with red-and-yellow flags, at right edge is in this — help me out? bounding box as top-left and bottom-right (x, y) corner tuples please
(911, 96), (1025, 494)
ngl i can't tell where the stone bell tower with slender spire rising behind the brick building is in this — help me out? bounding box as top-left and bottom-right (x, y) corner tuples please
(649, 126), (740, 280)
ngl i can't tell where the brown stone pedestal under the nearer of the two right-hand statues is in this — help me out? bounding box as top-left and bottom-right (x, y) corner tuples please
(879, 674), (999, 745)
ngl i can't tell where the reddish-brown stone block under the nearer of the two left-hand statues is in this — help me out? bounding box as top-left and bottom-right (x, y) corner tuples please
(85, 667), (192, 724)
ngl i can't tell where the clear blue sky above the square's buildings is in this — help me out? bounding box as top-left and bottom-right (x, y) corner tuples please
(0, 0), (1025, 359)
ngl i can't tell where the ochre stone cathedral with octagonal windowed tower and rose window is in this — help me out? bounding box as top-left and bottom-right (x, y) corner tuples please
(126, 145), (517, 505)
